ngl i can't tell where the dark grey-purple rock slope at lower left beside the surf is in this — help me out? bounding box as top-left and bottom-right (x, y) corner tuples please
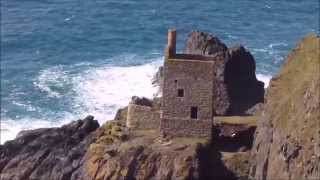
(0, 116), (99, 180)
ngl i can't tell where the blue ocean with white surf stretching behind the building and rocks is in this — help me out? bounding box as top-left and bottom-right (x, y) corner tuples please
(0, 0), (319, 143)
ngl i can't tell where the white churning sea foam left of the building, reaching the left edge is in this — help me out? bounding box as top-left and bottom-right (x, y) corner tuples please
(0, 57), (162, 144)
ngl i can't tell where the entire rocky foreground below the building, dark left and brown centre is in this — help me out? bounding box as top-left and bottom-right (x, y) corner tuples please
(0, 117), (255, 180)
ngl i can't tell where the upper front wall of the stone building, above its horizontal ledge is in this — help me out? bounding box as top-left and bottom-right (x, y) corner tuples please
(162, 59), (214, 120)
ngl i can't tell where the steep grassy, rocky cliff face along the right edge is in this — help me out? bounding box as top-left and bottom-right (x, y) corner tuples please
(250, 34), (320, 180)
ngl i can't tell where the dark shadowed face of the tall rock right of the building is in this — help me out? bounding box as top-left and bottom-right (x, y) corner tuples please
(224, 46), (265, 115)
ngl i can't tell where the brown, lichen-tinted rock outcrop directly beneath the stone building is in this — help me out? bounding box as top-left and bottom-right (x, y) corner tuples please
(81, 122), (203, 180)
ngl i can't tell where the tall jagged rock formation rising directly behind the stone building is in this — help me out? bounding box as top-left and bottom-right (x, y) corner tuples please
(153, 31), (264, 115)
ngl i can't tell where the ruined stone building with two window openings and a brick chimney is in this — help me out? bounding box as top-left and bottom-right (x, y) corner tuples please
(160, 29), (214, 138)
